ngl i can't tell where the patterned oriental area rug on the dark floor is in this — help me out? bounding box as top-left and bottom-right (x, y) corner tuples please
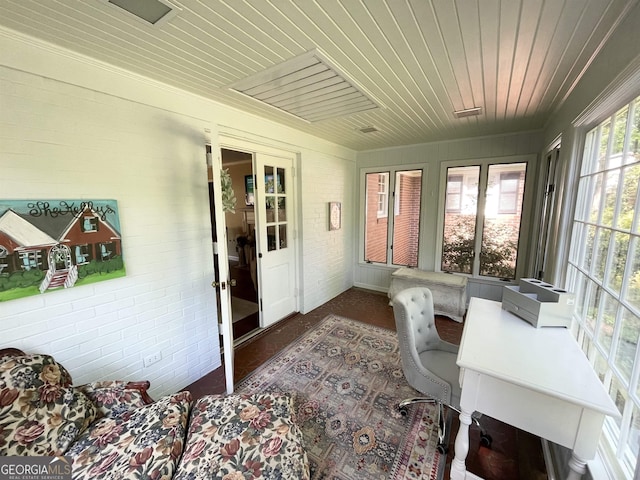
(236, 315), (445, 480)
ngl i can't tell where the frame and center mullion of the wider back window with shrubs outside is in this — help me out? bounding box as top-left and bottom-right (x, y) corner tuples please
(434, 154), (537, 283)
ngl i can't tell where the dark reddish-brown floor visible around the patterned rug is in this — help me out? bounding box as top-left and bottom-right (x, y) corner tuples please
(186, 288), (547, 480)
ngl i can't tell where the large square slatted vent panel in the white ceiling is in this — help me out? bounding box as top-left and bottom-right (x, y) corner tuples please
(229, 49), (382, 122)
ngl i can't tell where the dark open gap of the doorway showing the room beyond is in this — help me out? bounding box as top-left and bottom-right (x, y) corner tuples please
(220, 148), (260, 345)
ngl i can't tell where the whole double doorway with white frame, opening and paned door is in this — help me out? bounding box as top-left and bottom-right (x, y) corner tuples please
(210, 136), (299, 353)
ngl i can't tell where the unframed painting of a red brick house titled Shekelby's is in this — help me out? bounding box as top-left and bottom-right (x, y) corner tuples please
(0, 200), (125, 302)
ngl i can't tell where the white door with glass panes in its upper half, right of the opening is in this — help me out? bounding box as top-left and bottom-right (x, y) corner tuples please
(254, 153), (297, 327)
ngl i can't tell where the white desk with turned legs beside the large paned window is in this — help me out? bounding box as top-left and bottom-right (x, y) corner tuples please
(451, 298), (619, 480)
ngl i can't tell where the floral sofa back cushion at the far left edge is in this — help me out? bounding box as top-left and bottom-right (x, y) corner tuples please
(0, 354), (97, 455)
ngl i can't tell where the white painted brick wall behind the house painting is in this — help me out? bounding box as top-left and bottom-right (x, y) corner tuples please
(0, 67), (220, 396)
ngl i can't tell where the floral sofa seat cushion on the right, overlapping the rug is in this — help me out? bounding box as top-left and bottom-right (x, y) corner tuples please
(174, 394), (309, 480)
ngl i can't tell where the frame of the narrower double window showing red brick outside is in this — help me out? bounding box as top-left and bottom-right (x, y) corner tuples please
(358, 163), (428, 268)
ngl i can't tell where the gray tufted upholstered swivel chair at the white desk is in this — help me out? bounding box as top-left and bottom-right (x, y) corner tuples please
(392, 287), (491, 454)
